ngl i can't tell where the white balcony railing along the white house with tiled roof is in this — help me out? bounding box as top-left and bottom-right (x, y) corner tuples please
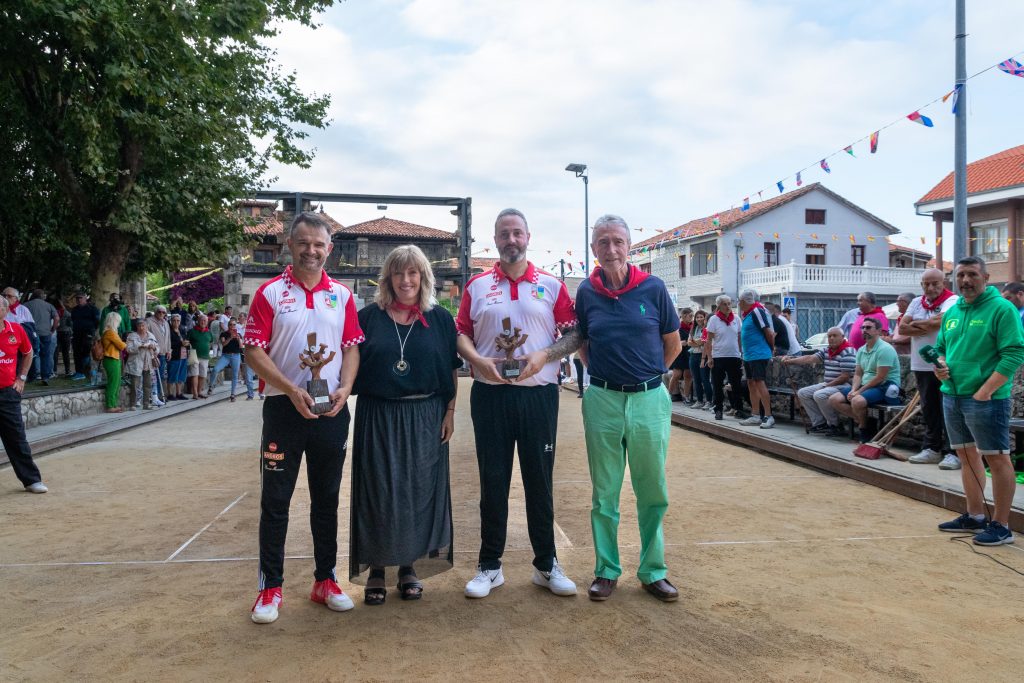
(739, 263), (922, 294)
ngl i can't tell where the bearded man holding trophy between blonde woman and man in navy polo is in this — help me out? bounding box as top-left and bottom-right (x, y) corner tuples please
(456, 209), (575, 598)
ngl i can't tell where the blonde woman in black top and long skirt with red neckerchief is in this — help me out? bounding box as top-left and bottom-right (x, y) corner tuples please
(348, 245), (462, 605)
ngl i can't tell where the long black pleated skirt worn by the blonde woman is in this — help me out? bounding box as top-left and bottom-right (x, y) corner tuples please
(348, 395), (454, 585)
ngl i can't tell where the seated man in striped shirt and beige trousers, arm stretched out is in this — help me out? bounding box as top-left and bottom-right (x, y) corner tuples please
(782, 328), (857, 436)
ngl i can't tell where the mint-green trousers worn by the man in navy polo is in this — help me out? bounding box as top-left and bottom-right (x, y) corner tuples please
(583, 386), (672, 584)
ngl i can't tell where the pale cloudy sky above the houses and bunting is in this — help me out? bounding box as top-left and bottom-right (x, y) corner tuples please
(271, 0), (1024, 272)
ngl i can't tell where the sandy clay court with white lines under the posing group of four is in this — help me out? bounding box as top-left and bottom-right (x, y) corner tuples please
(0, 380), (1024, 681)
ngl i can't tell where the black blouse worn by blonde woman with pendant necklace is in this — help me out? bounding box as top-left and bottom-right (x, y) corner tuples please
(352, 303), (462, 400)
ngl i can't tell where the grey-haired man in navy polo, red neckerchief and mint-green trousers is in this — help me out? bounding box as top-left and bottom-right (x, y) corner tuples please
(577, 214), (682, 602)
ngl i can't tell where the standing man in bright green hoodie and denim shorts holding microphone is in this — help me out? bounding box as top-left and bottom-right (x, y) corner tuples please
(935, 256), (1024, 546)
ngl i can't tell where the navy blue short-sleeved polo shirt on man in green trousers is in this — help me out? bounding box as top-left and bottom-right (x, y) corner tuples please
(575, 265), (679, 384)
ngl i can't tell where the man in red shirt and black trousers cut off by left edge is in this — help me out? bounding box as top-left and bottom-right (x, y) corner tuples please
(0, 296), (48, 494)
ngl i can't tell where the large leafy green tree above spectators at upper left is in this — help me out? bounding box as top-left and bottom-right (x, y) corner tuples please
(0, 0), (331, 300)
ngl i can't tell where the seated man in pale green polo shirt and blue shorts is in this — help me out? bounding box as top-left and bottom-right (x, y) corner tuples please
(828, 317), (900, 443)
